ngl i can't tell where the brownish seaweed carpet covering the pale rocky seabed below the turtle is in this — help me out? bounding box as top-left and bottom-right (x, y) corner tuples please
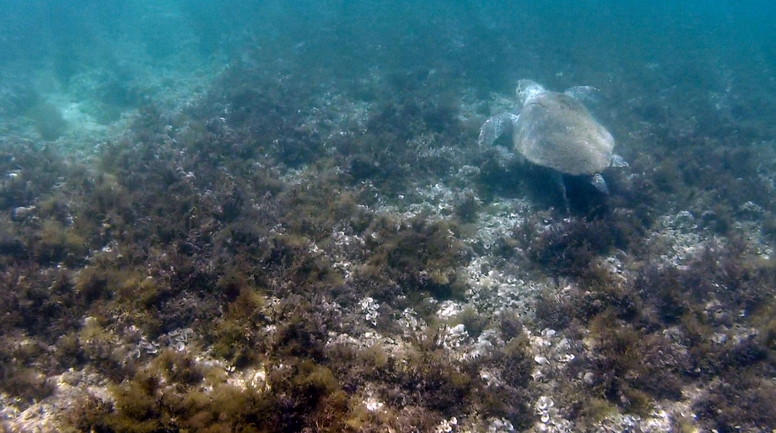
(0, 34), (776, 432)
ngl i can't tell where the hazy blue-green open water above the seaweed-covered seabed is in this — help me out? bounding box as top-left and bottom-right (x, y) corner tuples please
(0, 0), (776, 143)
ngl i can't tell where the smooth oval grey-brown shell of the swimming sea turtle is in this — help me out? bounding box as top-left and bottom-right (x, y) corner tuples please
(513, 91), (614, 175)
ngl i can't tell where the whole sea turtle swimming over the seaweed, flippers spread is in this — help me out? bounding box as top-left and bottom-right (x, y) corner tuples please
(479, 80), (628, 208)
